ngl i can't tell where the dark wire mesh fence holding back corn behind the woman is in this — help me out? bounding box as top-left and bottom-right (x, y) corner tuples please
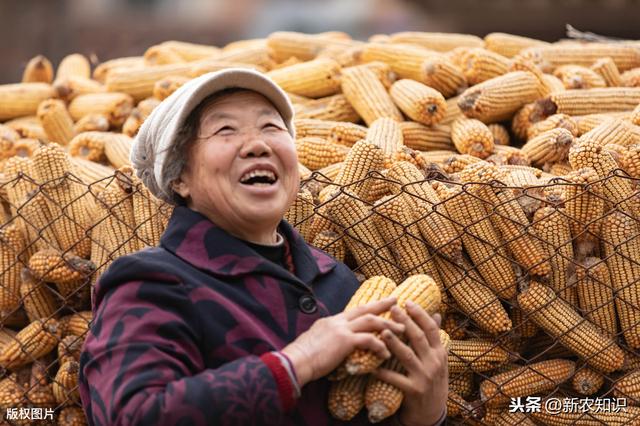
(0, 160), (640, 425)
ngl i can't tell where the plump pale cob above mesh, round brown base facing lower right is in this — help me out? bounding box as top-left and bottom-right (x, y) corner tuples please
(389, 79), (447, 126)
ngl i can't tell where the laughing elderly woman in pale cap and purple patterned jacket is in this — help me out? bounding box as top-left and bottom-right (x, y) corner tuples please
(80, 69), (447, 426)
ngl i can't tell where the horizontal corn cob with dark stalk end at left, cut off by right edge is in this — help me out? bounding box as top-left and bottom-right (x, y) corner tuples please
(537, 87), (640, 115)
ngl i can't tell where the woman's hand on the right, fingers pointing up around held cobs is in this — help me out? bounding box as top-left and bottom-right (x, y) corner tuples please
(376, 302), (449, 426)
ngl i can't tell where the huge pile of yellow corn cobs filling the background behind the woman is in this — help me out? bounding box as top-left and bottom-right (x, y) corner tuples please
(0, 32), (640, 425)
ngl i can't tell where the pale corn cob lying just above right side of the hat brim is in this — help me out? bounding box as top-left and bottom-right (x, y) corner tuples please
(267, 59), (340, 98)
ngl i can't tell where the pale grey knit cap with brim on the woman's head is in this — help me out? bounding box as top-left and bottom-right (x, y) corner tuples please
(130, 68), (295, 202)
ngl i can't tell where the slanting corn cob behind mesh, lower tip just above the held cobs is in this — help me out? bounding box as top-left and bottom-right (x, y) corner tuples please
(328, 192), (402, 280)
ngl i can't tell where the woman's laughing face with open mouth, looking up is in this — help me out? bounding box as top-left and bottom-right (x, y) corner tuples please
(174, 91), (299, 241)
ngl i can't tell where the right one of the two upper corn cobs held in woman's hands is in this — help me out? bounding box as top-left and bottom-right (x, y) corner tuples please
(345, 275), (441, 374)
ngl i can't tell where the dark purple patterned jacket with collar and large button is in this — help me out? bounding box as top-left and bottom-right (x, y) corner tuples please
(80, 207), (392, 425)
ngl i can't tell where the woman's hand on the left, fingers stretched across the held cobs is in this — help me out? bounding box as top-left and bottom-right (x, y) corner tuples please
(281, 297), (405, 387)
